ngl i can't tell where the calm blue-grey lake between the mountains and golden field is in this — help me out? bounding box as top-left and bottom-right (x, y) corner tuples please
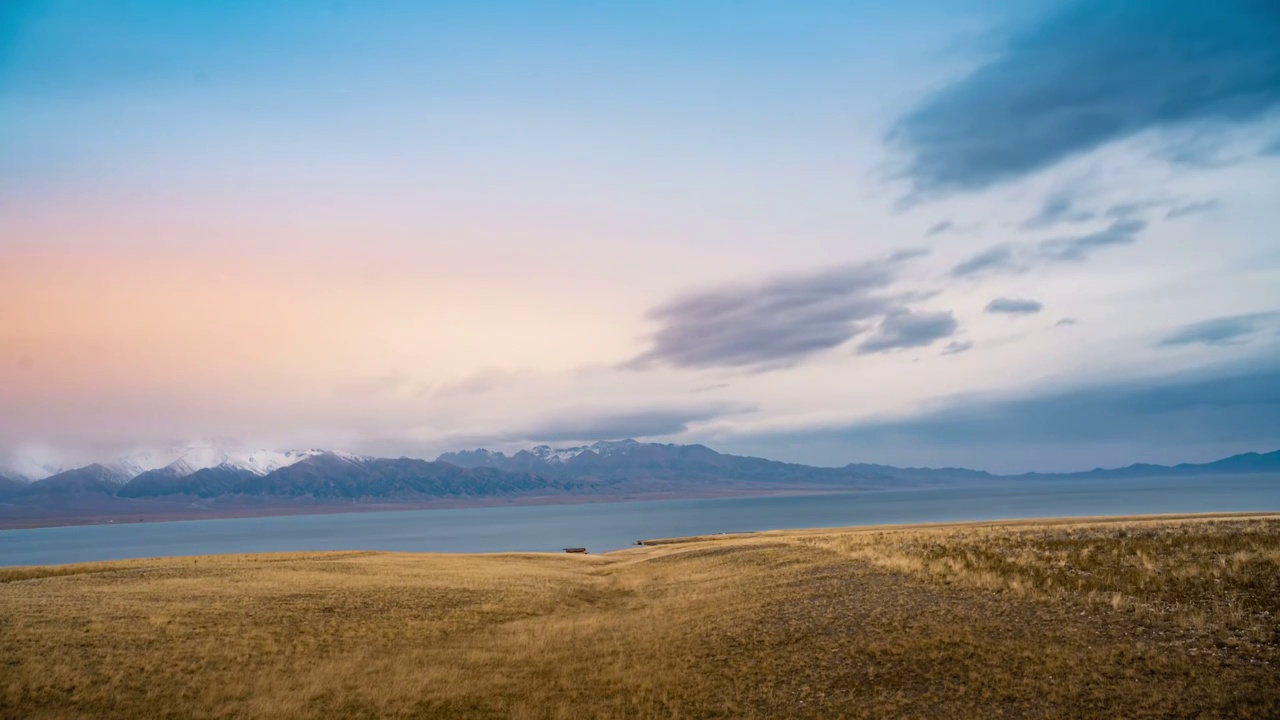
(0, 475), (1280, 565)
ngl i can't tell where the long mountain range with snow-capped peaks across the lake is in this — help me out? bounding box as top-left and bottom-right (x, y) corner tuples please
(0, 439), (1280, 503)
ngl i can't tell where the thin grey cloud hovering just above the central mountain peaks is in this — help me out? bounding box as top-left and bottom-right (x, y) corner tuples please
(519, 406), (744, 442)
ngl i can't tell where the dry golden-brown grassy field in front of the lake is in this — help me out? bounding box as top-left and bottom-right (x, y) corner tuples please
(0, 515), (1280, 719)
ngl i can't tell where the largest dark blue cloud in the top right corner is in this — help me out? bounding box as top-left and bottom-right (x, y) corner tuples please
(891, 0), (1280, 196)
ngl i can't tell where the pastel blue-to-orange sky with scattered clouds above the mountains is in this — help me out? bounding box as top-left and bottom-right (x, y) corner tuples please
(0, 0), (1280, 473)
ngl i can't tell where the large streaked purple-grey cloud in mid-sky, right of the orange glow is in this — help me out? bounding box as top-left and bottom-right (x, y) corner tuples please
(625, 250), (927, 370)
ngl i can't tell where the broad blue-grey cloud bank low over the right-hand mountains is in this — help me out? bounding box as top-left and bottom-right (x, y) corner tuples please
(722, 355), (1280, 471)
